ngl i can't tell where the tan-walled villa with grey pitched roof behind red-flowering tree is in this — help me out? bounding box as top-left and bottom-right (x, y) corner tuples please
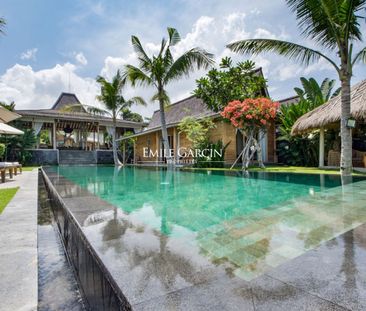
(120, 68), (284, 165)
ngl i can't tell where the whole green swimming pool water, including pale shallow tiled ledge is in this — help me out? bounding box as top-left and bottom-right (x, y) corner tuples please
(49, 166), (366, 280)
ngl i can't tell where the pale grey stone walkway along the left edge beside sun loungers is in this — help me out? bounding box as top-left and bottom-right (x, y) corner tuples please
(0, 169), (38, 311)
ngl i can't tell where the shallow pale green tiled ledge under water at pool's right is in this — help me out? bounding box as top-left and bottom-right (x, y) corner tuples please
(198, 181), (366, 281)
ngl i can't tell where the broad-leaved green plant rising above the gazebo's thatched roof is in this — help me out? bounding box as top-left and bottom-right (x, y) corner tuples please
(294, 77), (341, 111)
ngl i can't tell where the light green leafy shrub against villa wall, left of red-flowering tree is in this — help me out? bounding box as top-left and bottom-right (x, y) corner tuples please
(178, 116), (216, 148)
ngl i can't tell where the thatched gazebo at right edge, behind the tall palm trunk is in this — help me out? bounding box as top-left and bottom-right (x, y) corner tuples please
(292, 80), (366, 167)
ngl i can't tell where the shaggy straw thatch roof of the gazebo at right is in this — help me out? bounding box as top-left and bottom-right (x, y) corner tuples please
(291, 80), (366, 134)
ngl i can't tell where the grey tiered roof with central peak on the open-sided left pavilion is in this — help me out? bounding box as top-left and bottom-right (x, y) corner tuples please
(16, 93), (143, 128)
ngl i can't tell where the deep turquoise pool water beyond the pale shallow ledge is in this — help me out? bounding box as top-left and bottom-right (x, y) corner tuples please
(50, 166), (356, 235)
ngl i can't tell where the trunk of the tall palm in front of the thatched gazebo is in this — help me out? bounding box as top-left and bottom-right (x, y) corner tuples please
(340, 74), (352, 176)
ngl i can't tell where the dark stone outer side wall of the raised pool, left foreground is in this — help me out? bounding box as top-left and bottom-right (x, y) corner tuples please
(41, 169), (132, 311)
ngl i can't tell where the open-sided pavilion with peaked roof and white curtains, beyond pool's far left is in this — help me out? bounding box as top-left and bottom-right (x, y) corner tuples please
(15, 93), (145, 165)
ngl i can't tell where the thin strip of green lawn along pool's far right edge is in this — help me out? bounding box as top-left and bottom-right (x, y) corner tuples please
(183, 165), (366, 176)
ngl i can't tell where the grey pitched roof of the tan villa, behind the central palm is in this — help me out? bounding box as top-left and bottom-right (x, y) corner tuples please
(146, 96), (217, 130)
